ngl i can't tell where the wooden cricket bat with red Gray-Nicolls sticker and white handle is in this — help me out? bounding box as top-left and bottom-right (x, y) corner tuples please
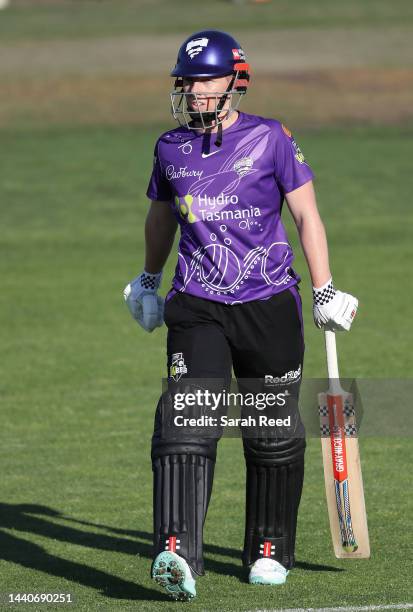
(318, 330), (370, 559)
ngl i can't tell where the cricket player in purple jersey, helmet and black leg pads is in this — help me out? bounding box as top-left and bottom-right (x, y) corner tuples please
(124, 30), (357, 600)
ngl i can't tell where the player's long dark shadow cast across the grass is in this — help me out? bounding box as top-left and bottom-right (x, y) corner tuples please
(0, 503), (342, 601)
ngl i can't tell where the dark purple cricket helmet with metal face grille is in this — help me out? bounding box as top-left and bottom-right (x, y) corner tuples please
(170, 30), (249, 130)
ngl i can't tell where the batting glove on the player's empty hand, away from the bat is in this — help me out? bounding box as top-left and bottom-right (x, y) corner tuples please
(123, 271), (164, 332)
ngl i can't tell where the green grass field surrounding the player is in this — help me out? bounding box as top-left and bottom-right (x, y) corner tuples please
(0, 0), (413, 612)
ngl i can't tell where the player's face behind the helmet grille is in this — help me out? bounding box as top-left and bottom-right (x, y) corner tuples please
(183, 76), (231, 112)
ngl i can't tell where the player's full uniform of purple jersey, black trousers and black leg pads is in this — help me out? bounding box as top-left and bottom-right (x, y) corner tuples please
(147, 111), (313, 579)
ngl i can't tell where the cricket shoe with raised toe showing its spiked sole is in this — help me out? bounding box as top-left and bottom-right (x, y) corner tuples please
(151, 550), (196, 601)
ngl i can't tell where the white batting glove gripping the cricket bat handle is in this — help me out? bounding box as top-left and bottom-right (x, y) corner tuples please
(313, 278), (358, 331)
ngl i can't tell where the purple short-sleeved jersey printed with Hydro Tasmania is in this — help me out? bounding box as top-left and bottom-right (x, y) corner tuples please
(147, 113), (313, 304)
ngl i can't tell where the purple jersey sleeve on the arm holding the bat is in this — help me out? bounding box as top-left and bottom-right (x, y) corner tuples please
(275, 123), (314, 193)
